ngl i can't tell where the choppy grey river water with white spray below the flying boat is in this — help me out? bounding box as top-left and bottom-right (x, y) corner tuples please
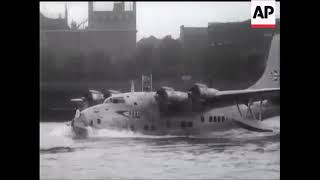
(40, 117), (280, 179)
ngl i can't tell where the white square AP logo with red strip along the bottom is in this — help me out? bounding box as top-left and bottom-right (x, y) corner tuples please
(251, 0), (276, 28)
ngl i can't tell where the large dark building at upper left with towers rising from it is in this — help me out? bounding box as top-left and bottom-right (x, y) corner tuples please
(40, 2), (137, 80)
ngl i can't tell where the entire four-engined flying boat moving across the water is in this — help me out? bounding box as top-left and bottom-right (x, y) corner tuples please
(71, 35), (280, 137)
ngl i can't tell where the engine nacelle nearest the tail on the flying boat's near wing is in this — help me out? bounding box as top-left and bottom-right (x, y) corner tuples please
(190, 83), (218, 99)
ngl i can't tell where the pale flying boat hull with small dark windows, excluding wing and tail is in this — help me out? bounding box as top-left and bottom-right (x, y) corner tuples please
(73, 92), (280, 135)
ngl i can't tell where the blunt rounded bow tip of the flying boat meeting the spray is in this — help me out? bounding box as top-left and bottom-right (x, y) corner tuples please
(71, 110), (88, 138)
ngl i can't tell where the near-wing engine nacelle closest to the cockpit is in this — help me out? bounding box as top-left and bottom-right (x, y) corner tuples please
(157, 87), (189, 104)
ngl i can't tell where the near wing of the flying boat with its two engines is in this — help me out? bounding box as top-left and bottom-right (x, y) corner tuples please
(156, 83), (280, 107)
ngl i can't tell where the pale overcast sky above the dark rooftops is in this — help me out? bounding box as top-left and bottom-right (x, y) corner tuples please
(40, 2), (280, 40)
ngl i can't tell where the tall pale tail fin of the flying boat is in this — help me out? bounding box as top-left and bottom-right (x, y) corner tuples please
(249, 34), (280, 89)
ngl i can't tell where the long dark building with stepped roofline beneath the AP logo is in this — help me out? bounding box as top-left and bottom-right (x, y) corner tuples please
(180, 20), (273, 55)
